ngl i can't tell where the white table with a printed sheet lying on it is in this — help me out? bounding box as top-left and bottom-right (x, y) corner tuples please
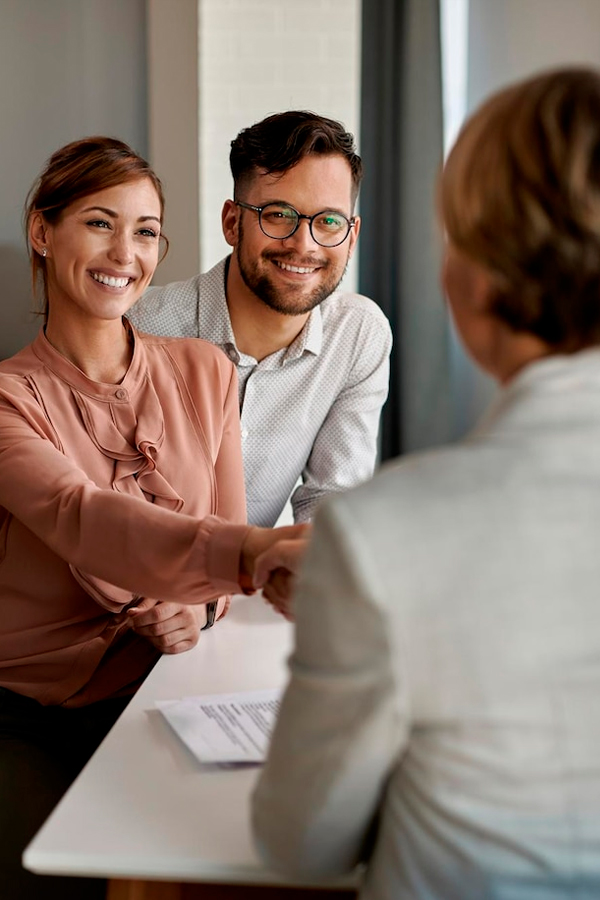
(23, 597), (356, 900)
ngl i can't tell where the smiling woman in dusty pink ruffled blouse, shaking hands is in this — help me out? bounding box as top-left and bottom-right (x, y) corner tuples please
(0, 137), (300, 900)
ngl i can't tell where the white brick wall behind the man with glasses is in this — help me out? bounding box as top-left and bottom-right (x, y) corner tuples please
(198, 0), (361, 289)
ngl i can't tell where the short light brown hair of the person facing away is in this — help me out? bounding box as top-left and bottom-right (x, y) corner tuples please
(438, 68), (600, 352)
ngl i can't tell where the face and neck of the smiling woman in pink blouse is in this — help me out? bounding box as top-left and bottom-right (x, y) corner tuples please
(29, 177), (162, 381)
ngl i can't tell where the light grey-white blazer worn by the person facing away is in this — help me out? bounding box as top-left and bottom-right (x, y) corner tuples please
(254, 350), (600, 900)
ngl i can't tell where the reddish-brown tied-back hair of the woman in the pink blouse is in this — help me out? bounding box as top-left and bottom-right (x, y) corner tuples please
(24, 137), (168, 315)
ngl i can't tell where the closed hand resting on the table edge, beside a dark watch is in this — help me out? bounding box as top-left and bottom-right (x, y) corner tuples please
(127, 598), (206, 653)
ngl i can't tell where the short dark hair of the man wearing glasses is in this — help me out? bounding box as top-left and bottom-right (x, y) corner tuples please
(229, 110), (363, 204)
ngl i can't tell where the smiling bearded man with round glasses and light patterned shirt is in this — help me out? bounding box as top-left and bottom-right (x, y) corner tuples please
(129, 111), (391, 526)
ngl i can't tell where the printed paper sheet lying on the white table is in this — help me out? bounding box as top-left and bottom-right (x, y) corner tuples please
(155, 690), (281, 763)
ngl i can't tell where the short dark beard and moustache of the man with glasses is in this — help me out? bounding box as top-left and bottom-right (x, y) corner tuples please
(235, 221), (348, 316)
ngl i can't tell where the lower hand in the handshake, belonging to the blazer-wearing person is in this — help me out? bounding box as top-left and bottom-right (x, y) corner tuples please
(254, 530), (310, 621)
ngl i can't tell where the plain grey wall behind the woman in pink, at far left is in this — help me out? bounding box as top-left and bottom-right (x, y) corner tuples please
(0, 0), (148, 358)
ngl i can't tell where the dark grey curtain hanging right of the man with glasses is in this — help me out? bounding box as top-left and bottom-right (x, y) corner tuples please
(359, 0), (451, 460)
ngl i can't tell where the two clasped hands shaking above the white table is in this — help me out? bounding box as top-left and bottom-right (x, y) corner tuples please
(239, 525), (311, 620)
